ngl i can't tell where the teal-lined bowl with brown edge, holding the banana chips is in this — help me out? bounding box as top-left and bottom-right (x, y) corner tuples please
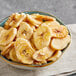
(0, 11), (70, 70)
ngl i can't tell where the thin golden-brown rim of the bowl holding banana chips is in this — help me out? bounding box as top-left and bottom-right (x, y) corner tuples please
(0, 11), (71, 68)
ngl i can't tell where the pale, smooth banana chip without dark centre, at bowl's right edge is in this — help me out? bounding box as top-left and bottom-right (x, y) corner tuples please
(51, 35), (71, 50)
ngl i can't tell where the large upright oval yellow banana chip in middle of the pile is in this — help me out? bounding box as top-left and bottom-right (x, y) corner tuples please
(33, 26), (51, 49)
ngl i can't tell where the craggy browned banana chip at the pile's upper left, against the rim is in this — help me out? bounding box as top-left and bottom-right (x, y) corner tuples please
(4, 13), (26, 29)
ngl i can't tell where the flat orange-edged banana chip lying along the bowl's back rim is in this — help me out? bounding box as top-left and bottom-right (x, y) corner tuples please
(32, 14), (55, 21)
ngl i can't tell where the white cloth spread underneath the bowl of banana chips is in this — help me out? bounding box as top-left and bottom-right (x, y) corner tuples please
(0, 24), (76, 76)
